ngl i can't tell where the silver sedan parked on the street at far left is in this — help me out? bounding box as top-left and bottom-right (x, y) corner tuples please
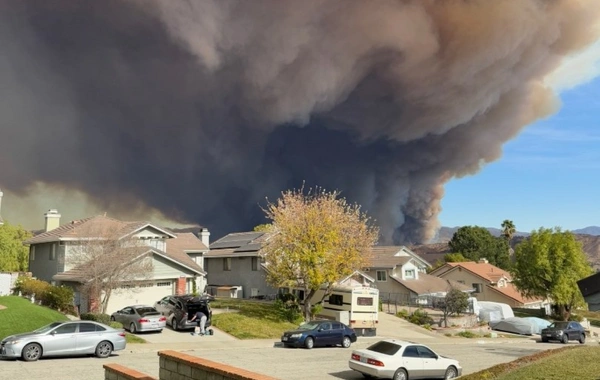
(0, 321), (126, 362)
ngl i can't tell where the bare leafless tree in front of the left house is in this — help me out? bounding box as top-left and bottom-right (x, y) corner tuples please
(66, 218), (153, 313)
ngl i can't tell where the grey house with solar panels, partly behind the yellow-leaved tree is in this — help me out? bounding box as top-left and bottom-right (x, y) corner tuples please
(204, 232), (277, 298)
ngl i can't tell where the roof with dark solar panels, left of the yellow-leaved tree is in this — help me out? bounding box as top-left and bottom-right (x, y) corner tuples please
(204, 231), (268, 258)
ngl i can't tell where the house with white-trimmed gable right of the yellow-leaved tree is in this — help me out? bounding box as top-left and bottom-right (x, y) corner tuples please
(364, 246), (471, 304)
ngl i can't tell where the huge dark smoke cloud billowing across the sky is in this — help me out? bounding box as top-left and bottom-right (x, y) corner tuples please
(0, 0), (600, 242)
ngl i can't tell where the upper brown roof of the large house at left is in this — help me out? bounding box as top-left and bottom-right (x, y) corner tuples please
(24, 215), (175, 244)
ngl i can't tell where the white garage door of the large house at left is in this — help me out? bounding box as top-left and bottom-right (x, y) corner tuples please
(106, 280), (175, 314)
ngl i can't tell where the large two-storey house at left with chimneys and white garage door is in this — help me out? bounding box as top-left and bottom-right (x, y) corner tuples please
(24, 210), (210, 314)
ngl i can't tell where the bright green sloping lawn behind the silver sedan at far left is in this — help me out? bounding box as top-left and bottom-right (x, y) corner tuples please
(0, 296), (68, 339)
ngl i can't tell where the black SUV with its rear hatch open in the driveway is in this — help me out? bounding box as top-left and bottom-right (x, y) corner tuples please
(154, 294), (212, 331)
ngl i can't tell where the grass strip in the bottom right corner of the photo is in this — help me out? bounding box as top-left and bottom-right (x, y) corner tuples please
(461, 346), (600, 380)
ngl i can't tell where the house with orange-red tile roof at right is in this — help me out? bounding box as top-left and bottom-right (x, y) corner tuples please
(429, 259), (548, 308)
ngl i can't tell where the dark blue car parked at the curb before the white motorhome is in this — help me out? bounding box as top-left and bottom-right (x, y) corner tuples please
(281, 320), (356, 349)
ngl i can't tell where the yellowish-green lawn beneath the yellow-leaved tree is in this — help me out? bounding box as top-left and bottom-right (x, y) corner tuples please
(210, 299), (298, 339)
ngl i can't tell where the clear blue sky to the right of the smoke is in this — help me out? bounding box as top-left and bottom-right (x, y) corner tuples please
(439, 78), (600, 232)
